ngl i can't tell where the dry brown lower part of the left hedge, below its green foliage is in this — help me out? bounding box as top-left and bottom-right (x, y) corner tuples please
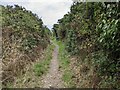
(2, 27), (46, 86)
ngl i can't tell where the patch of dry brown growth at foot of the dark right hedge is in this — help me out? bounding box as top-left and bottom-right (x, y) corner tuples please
(70, 57), (100, 88)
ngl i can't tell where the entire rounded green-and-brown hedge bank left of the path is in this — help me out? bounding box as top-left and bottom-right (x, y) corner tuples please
(0, 5), (50, 85)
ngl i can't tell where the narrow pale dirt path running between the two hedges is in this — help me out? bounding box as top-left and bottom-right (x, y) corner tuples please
(43, 44), (63, 88)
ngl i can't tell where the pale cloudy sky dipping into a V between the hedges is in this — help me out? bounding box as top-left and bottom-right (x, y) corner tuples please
(0, 0), (73, 29)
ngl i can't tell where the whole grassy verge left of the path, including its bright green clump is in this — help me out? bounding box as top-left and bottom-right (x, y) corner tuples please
(5, 44), (54, 88)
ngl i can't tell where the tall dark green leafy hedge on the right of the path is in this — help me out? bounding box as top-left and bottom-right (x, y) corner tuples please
(53, 2), (120, 88)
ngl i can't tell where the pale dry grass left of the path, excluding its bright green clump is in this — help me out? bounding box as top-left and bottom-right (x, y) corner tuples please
(7, 45), (54, 88)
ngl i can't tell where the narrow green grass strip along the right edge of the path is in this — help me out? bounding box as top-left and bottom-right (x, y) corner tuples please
(57, 41), (74, 88)
